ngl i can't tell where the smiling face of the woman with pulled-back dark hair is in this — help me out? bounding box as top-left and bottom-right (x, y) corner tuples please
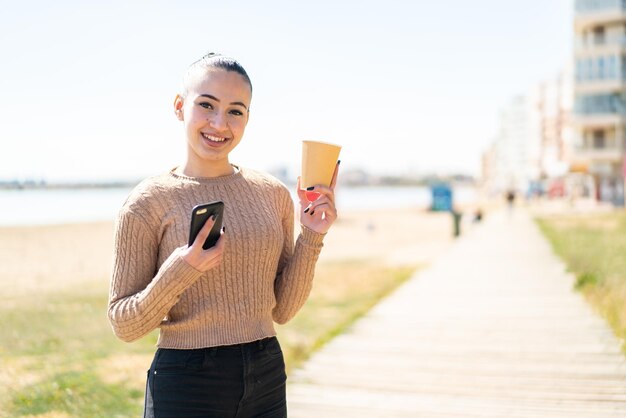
(174, 68), (251, 166)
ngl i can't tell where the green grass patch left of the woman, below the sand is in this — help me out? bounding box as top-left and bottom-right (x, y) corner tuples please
(0, 283), (156, 417)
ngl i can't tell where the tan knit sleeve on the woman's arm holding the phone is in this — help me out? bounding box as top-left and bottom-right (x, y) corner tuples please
(108, 210), (202, 342)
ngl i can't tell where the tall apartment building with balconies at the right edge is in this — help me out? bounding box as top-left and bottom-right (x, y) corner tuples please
(570, 0), (626, 205)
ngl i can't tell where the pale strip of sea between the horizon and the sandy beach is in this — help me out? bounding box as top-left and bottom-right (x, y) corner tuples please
(0, 186), (477, 226)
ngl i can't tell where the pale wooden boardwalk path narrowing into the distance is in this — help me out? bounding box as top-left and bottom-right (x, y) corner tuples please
(288, 212), (626, 418)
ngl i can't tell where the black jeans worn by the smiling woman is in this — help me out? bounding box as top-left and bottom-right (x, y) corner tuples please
(144, 337), (287, 418)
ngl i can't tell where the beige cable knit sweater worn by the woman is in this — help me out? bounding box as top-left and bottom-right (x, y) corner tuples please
(108, 168), (324, 349)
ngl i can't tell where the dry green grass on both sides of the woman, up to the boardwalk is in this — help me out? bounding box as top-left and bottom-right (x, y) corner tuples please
(0, 261), (413, 418)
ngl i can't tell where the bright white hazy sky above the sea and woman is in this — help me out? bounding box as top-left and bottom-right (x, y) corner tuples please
(0, 0), (573, 181)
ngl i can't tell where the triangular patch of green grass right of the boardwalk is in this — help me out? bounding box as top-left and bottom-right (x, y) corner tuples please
(537, 211), (626, 352)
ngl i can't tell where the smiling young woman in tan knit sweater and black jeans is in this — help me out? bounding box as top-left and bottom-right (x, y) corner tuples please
(108, 54), (338, 418)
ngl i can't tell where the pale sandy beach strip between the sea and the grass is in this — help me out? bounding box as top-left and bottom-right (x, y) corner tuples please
(0, 209), (452, 296)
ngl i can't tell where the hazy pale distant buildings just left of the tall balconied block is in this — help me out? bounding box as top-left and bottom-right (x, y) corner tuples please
(482, 72), (576, 201)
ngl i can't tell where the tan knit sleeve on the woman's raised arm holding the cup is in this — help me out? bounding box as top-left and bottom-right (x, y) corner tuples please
(272, 196), (325, 324)
